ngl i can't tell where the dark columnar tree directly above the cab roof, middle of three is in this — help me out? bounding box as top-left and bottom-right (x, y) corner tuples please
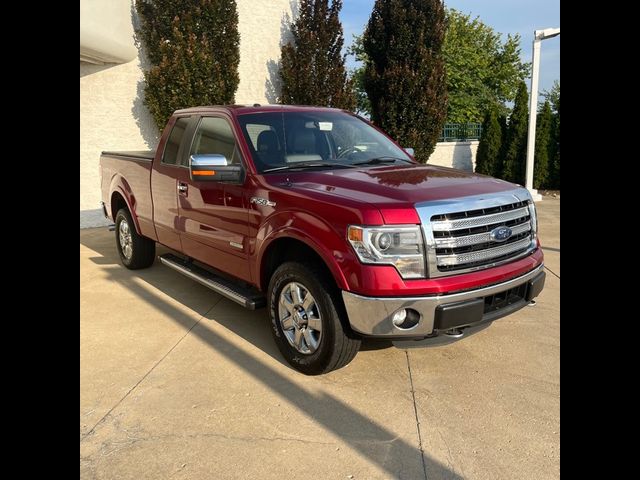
(280, 0), (356, 110)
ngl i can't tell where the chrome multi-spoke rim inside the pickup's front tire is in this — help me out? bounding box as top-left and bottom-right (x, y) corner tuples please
(278, 282), (322, 355)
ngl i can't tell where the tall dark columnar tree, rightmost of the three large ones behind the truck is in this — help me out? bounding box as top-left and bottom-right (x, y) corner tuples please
(362, 0), (447, 163)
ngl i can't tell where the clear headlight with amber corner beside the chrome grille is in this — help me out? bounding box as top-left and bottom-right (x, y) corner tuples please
(347, 225), (426, 278)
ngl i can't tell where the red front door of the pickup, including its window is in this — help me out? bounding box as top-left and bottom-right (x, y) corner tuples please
(178, 115), (251, 281)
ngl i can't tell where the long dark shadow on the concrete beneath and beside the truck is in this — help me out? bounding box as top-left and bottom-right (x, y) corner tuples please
(80, 229), (462, 480)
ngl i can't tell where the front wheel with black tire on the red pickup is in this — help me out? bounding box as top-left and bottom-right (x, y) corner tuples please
(268, 262), (360, 375)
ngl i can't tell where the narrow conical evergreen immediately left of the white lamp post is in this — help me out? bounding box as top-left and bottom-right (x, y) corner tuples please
(502, 82), (529, 185)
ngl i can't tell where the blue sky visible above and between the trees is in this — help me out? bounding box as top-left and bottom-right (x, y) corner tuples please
(340, 0), (560, 91)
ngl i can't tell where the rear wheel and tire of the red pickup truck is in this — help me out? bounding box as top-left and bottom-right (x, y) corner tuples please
(116, 208), (156, 270)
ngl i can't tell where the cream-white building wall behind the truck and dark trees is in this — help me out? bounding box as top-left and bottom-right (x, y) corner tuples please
(80, 0), (296, 228)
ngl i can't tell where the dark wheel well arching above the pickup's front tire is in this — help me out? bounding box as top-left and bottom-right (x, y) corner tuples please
(260, 238), (335, 292)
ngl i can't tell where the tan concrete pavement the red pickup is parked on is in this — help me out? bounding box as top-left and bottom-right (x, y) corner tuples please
(80, 197), (560, 480)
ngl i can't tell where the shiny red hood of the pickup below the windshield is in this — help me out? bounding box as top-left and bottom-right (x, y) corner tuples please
(265, 165), (515, 208)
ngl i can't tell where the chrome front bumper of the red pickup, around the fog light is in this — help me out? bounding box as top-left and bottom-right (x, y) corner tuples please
(342, 265), (544, 338)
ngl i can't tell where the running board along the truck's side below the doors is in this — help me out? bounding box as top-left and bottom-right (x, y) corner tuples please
(159, 253), (267, 310)
